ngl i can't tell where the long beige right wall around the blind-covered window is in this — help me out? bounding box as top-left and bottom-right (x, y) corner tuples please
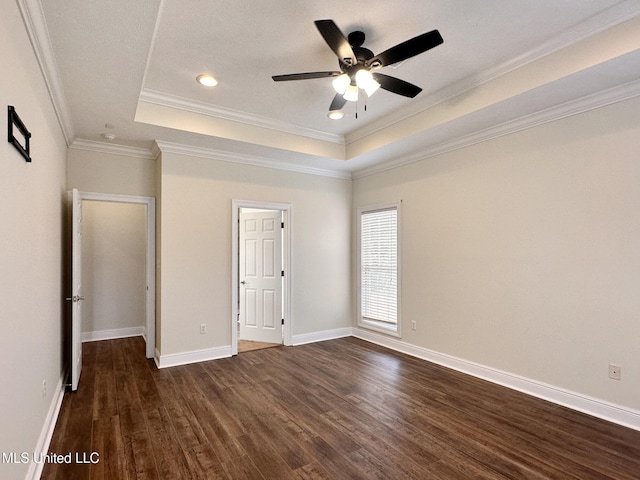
(353, 98), (640, 410)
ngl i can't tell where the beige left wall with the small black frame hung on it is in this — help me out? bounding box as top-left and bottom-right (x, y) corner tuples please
(0, 2), (66, 479)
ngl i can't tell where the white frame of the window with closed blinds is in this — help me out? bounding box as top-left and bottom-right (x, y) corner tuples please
(356, 202), (402, 337)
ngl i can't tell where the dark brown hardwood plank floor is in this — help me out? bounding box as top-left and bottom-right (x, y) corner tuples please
(42, 337), (640, 480)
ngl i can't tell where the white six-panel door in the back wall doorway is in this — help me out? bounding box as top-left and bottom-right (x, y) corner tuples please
(239, 210), (283, 343)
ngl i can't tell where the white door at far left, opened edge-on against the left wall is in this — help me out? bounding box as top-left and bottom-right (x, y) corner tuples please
(67, 189), (84, 391)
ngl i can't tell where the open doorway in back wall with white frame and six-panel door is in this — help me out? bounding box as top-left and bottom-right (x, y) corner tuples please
(231, 200), (291, 355)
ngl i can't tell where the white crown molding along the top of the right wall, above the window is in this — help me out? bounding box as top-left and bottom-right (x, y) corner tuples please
(352, 80), (640, 179)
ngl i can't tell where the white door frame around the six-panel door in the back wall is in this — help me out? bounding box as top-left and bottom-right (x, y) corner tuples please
(231, 199), (293, 355)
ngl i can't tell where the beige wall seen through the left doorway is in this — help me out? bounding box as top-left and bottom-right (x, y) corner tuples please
(82, 201), (147, 338)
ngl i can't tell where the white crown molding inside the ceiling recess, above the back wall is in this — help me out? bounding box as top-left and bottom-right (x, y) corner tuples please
(140, 89), (345, 146)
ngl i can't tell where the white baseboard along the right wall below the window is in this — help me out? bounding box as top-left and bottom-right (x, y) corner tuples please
(353, 328), (640, 431)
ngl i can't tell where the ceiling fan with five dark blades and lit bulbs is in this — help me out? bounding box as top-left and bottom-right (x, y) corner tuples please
(271, 20), (444, 116)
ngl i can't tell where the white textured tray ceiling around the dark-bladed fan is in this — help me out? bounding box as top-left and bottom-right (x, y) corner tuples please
(37, 0), (640, 176)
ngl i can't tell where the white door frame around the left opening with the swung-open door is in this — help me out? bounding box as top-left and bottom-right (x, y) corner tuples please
(78, 191), (156, 358)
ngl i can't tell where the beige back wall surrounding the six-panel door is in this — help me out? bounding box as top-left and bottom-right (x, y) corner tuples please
(159, 153), (352, 356)
